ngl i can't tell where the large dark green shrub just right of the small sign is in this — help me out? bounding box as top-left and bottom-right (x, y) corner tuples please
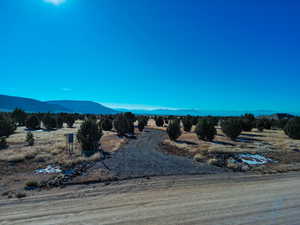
(77, 120), (103, 156)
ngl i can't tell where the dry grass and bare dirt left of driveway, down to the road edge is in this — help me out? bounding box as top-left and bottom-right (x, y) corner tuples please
(0, 121), (127, 198)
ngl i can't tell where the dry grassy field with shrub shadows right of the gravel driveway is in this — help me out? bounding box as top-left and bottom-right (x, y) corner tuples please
(163, 128), (300, 173)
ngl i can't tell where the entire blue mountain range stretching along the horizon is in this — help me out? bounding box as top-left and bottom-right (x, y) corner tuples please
(0, 95), (300, 116)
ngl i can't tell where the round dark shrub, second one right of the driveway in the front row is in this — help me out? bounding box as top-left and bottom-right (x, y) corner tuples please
(195, 119), (217, 141)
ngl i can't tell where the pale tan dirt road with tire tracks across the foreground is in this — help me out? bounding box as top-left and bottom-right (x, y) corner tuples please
(0, 173), (300, 225)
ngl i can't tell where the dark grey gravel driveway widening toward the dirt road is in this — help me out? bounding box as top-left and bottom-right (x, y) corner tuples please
(95, 129), (223, 178)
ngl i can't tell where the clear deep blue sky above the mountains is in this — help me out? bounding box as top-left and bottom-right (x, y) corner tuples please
(0, 0), (300, 112)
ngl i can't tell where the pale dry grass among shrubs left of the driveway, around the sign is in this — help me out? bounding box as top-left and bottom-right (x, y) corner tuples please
(0, 121), (127, 165)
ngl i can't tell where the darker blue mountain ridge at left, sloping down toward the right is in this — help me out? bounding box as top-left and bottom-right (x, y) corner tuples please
(0, 95), (118, 114)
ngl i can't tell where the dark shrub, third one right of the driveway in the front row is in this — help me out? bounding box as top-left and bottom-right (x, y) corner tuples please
(221, 119), (242, 140)
